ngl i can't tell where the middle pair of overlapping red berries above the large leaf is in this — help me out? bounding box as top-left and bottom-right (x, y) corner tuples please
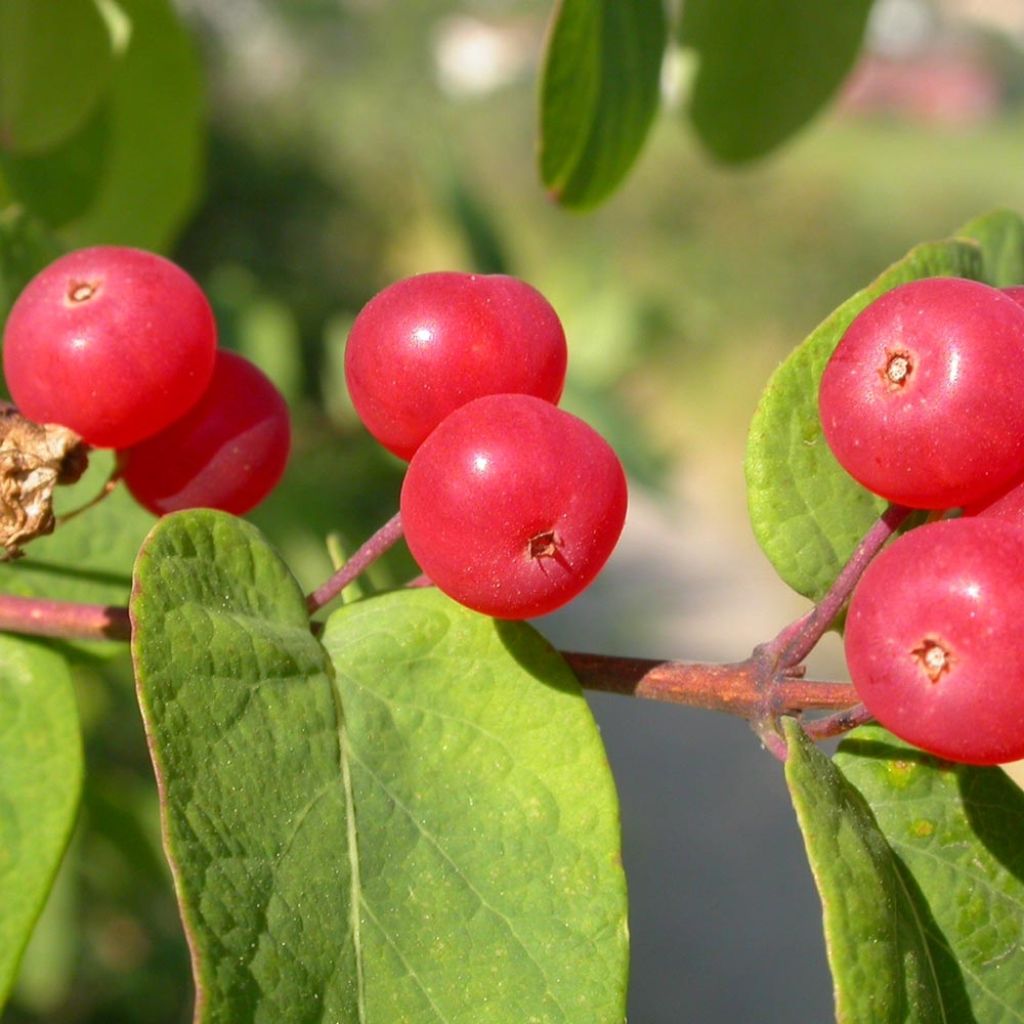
(345, 272), (627, 618)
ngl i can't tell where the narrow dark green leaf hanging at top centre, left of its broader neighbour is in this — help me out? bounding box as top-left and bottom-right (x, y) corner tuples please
(540, 0), (668, 208)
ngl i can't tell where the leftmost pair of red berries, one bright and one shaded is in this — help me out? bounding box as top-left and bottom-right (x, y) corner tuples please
(3, 246), (291, 515)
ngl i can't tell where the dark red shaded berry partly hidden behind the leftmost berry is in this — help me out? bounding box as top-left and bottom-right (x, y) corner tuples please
(120, 350), (291, 515)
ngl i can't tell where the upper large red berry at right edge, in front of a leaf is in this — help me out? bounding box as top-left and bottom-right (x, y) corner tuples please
(819, 278), (1024, 509)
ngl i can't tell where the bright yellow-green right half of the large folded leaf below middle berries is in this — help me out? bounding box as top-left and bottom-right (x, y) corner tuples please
(324, 591), (627, 1024)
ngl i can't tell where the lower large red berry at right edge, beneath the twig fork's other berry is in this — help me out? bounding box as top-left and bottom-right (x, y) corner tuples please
(845, 518), (1024, 764)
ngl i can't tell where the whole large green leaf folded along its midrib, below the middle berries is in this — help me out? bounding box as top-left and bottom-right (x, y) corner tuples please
(131, 511), (626, 1024)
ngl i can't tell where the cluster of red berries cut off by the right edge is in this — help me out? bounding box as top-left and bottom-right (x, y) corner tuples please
(819, 278), (1024, 764)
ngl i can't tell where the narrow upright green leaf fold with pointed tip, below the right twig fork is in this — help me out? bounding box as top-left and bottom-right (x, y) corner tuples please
(783, 719), (942, 1024)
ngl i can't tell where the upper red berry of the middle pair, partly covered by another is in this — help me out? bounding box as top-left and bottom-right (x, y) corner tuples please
(345, 271), (566, 459)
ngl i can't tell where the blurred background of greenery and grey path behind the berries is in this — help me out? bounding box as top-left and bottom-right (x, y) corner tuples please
(4, 0), (1024, 1024)
